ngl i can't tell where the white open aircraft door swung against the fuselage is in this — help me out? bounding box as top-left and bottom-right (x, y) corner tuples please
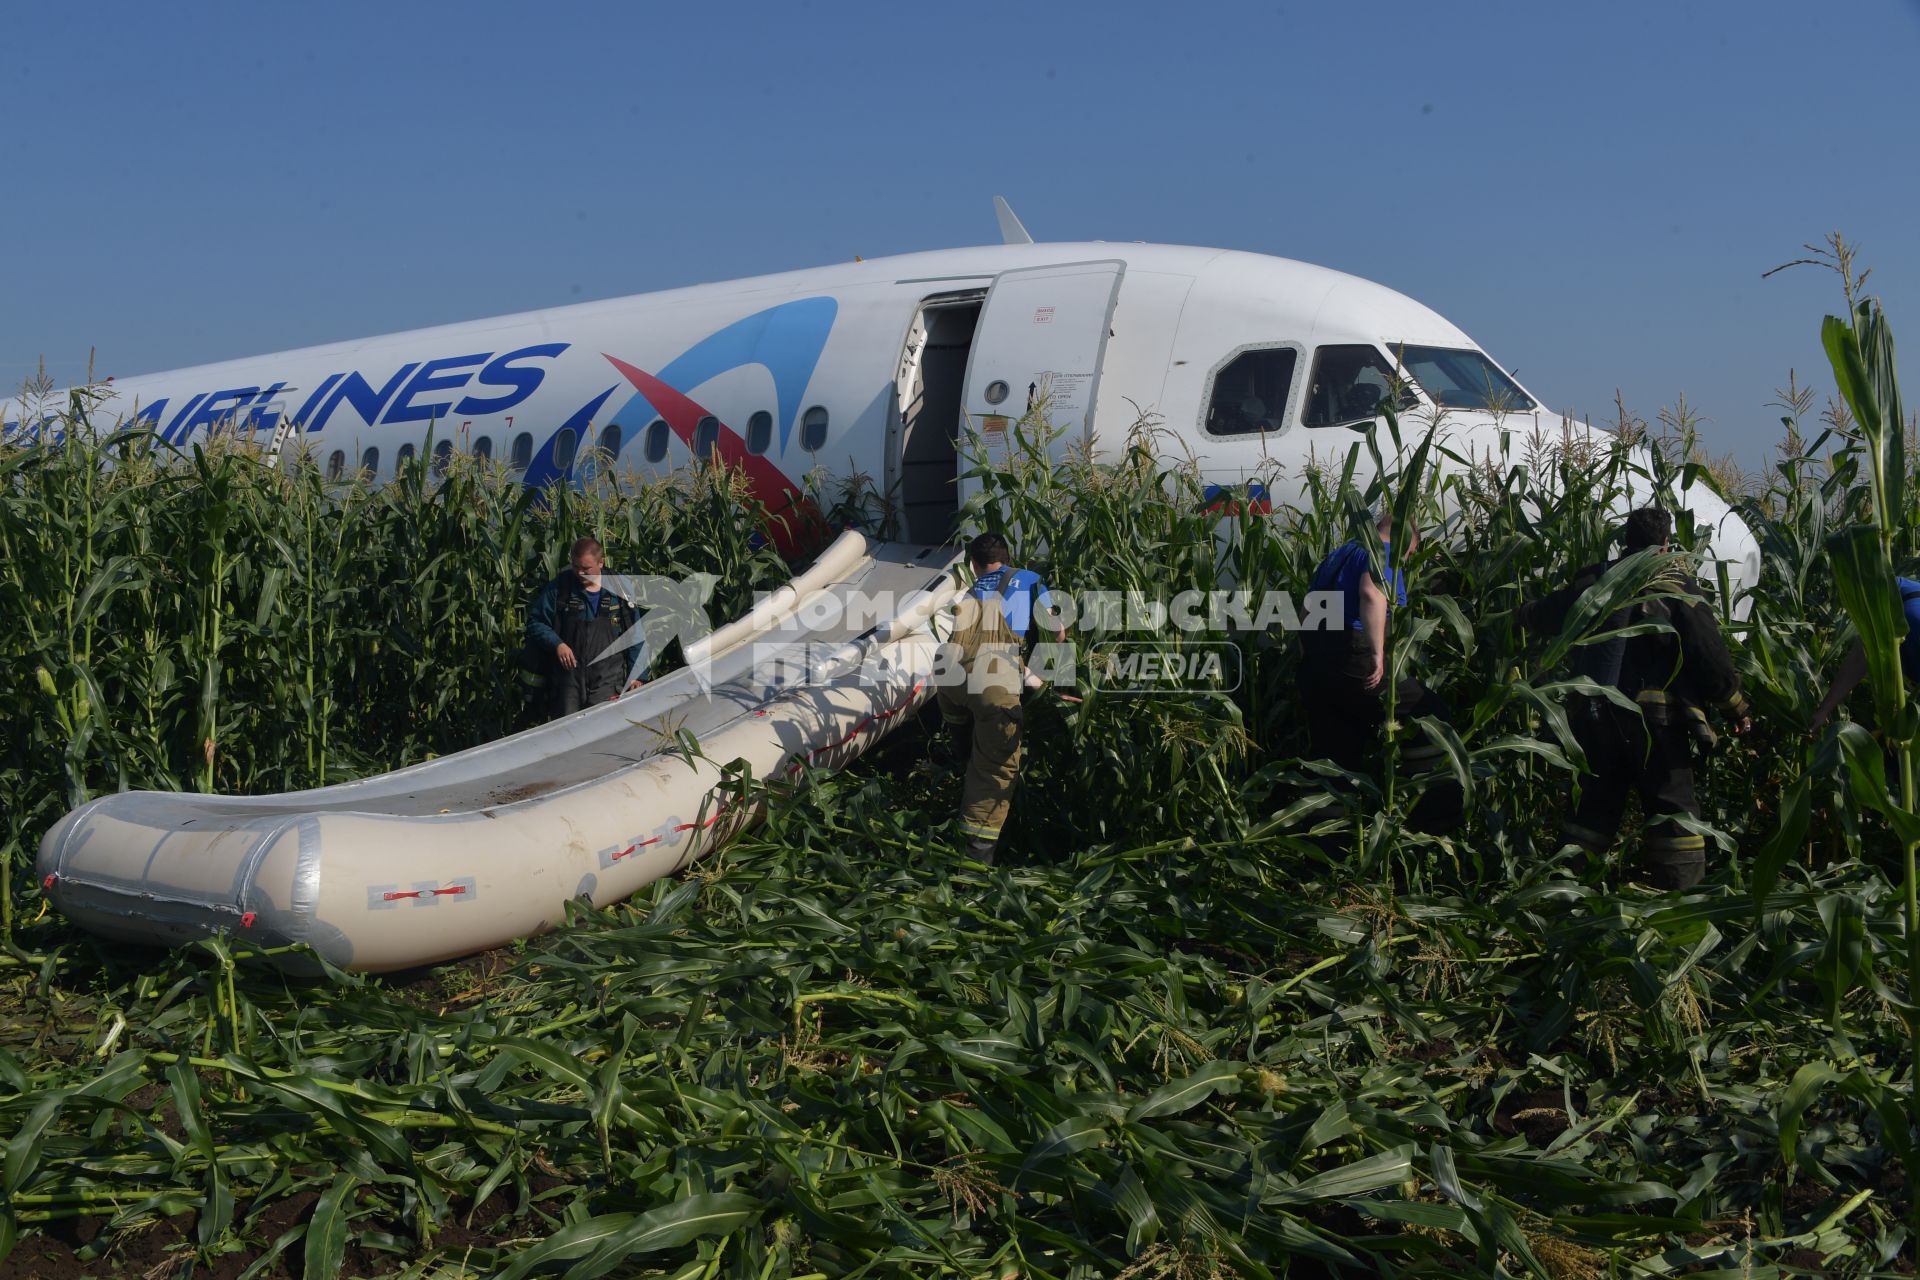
(960, 261), (1125, 479)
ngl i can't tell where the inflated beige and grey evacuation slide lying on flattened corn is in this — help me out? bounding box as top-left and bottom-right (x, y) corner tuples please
(38, 533), (975, 971)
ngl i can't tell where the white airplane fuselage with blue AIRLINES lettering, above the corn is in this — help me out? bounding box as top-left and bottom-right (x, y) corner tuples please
(6, 244), (1759, 593)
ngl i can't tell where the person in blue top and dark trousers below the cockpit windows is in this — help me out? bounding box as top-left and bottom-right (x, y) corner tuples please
(1300, 507), (1465, 831)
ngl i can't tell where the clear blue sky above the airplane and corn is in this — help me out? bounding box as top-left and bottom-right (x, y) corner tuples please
(0, 0), (1920, 464)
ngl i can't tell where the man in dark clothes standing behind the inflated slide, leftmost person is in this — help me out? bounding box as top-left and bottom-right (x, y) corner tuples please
(526, 537), (647, 718)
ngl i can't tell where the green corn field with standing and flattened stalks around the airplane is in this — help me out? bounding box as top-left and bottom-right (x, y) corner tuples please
(0, 280), (1920, 1280)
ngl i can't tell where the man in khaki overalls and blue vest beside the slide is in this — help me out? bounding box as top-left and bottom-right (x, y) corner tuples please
(935, 533), (1066, 862)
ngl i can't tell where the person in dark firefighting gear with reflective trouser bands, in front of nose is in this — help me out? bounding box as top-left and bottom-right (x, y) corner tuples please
(1519, 507), (1751, 889)
